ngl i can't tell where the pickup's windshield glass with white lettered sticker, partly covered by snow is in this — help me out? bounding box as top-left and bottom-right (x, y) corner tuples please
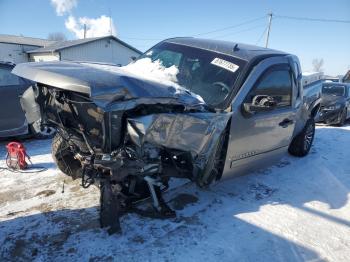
(139, 42), (246, 106)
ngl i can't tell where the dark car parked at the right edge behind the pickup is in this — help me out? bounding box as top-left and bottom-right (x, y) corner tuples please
(318, 82), (350, 126)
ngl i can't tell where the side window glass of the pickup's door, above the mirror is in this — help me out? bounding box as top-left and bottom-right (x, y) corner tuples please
(248, 69), (293, 107)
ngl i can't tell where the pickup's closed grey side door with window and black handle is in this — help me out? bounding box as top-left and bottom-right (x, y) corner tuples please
(224, 57), (296, 175)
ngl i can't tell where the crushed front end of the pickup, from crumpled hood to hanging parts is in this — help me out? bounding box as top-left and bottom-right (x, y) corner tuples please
(14, 61), (230, 233)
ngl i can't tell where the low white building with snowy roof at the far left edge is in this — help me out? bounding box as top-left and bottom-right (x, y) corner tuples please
(0, 35), (55, 64)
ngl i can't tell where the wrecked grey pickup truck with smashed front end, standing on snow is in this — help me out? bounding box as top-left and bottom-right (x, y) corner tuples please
(13, 38), (319, 233)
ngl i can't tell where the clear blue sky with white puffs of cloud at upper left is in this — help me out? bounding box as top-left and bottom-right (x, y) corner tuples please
(0, 0), (350, 75)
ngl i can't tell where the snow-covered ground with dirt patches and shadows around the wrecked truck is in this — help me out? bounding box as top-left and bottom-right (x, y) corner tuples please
(0, 126), (350, 261)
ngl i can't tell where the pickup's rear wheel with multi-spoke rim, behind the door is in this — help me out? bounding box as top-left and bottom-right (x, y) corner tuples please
(288, 118), (315, 157)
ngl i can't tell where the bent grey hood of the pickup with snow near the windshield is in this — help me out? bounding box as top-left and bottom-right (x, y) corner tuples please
(12, 62), (204, 106)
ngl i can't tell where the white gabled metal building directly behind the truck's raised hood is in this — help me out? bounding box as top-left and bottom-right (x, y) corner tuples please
(27, 36), (141, 65)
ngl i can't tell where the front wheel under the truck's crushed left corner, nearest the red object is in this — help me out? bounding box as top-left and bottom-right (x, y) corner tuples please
(52, 133), (82, 179)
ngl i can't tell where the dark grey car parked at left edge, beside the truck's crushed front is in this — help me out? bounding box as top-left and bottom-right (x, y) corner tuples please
(0, 62), (54, 138)
